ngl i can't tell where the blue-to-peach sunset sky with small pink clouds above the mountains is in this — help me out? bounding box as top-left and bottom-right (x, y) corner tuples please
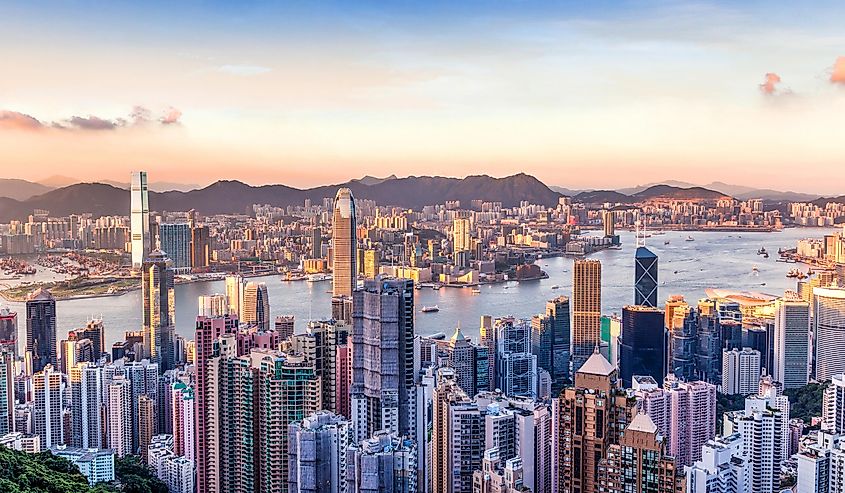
(0, 0), (845, 194)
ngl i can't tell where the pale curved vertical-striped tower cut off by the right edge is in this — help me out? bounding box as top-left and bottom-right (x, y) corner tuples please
(813, 288), (845, 382)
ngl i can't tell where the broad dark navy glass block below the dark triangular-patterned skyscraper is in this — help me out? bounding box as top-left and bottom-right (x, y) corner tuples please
(619, 305), (666, 387)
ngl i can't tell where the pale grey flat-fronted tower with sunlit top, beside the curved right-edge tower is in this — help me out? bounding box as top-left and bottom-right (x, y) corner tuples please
(769, 291), (812, 389)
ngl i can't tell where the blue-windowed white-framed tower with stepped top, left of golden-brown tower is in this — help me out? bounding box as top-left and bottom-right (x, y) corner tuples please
(493, 318), (537, 398)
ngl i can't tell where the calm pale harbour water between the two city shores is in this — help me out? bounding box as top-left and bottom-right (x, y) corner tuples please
(0, 228), (834, 347)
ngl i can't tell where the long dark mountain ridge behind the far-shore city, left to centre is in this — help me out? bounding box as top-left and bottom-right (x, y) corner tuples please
(0, 173), (560, 222)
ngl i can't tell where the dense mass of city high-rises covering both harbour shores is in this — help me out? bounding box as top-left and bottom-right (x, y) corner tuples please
(0, 173), (845, 493)
